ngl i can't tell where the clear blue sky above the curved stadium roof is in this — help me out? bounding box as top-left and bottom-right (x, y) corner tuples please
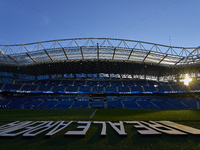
(0, 0), (200, 47)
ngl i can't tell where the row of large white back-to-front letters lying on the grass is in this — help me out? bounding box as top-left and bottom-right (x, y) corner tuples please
(0, 121), (200, 137)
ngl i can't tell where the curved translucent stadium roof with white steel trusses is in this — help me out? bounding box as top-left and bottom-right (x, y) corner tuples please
(0, 38), (200, 76)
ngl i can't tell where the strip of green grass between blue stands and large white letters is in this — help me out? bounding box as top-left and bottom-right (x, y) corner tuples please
(0, 109), (200, 121)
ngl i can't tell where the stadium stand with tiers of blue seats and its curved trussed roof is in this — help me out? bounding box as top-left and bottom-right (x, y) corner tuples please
(0, 38), (200, 109)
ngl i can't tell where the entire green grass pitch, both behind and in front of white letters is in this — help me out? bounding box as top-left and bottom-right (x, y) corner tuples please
(0, 109), (200, 150)
